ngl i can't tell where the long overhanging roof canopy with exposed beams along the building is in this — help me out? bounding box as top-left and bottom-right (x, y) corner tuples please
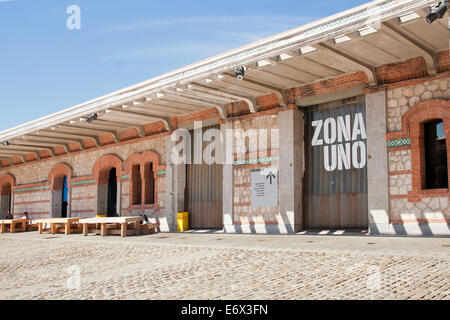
(0, 0), (449, 168)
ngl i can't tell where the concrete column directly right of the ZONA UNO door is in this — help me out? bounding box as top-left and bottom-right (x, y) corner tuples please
(366, 91), (389, 234)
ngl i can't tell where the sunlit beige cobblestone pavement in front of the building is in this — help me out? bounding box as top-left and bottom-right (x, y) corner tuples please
(0, 233), (450, 300)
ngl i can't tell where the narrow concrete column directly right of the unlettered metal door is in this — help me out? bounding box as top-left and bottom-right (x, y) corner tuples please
(220, 122), (234, 232)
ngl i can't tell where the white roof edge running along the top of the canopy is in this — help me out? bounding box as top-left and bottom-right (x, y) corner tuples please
(0, 0), (436, 141)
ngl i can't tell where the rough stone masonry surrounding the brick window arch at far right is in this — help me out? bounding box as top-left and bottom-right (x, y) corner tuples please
(387, 77), (450, 234)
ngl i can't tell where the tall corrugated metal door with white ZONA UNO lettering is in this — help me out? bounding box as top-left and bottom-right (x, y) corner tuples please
(303, 96), (368, 228)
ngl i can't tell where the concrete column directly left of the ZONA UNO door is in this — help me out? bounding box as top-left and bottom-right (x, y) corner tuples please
(278, 108), (304, 233)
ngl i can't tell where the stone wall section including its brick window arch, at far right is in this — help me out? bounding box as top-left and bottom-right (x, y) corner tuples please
(386, 75), (450, 235)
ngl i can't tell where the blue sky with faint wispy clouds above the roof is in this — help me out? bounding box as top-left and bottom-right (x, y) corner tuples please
(0, 0), (368, 131)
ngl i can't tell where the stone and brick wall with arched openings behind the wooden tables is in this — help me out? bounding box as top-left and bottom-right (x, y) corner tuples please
(0, 135), (166, 224)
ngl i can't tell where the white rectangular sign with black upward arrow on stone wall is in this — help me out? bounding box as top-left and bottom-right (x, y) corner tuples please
(251, 168), (278, 207)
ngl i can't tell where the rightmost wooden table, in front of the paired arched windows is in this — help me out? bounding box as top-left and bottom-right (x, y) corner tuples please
(80, 217), (144, 237)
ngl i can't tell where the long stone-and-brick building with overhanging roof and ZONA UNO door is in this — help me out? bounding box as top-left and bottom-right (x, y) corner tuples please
(0, 1), (450, 235)
